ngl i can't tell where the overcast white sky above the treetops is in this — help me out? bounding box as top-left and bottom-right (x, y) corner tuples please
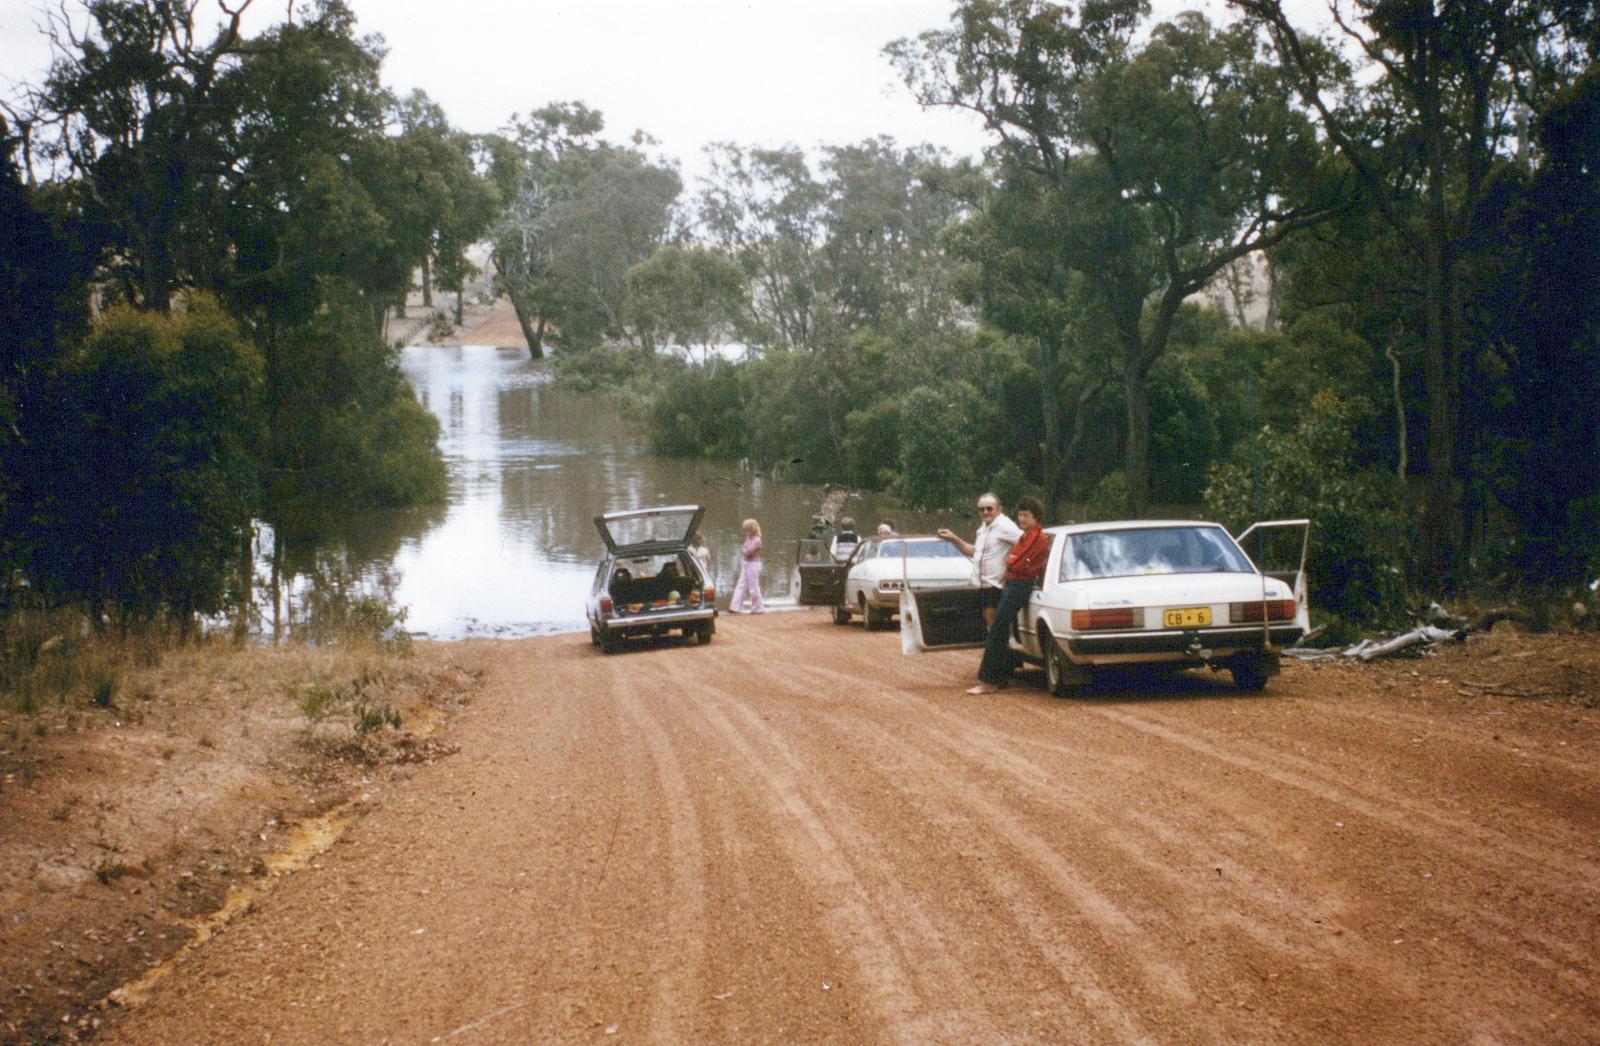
(0, 0), (1315, 188)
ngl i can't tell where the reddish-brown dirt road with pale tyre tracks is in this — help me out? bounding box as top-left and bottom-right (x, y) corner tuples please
(101, 613), (1600, 1043)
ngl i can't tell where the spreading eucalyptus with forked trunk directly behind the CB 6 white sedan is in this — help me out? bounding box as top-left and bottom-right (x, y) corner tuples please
(888, 0), (1333, 510)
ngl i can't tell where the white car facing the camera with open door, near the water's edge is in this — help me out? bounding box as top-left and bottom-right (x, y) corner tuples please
(797, 534), (973, 629)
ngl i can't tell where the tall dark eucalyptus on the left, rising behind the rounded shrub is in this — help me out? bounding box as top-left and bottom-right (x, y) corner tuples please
(21, 0), (453, 534)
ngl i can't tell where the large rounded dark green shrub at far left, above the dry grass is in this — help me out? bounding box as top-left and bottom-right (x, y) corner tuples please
(5, 297), (262, 622)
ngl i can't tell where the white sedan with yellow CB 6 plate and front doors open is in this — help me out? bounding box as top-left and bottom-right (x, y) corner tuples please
(901, 520), (1310, 697)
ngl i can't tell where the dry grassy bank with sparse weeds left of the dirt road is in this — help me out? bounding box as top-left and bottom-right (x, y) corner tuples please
(0, 630), (480, 1041)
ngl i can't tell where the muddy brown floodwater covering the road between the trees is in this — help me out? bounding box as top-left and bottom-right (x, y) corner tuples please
(258, 345), (976, 640)
